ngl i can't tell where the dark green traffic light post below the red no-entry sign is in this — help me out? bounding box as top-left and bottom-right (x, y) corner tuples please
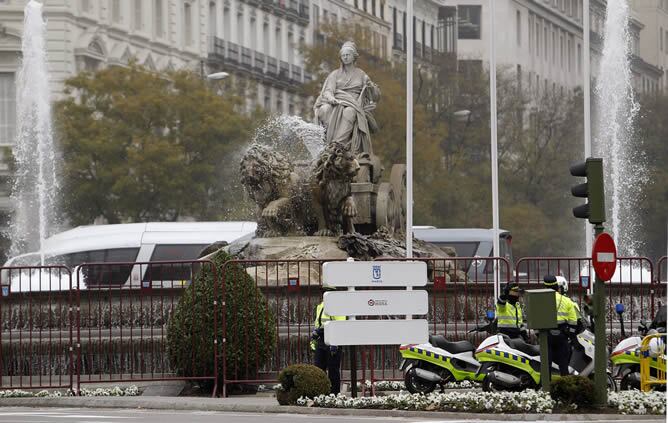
(588, 224), (608, 407)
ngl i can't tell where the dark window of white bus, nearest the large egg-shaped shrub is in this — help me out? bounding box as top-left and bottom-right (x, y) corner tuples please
(142, 244), (208, 282)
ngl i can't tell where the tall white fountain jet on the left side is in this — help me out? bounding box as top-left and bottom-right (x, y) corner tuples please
(10, 0), (58, 263)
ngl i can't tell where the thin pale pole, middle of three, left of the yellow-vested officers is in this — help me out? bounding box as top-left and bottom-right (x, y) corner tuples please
(488, 0), (501, 299)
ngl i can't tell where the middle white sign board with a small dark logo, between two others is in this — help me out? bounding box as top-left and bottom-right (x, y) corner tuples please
(323, 290), (428, 316)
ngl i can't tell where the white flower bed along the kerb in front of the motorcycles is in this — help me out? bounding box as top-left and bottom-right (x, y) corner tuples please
(297, 390), (666, 414)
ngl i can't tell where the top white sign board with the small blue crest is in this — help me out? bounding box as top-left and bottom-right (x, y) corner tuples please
(322, 261), (427, 287)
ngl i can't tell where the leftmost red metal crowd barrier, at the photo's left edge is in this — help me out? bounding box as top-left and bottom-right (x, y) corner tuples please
(0, 266), (77, 389)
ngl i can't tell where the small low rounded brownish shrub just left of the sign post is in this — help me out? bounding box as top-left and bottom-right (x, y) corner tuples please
(276, 364), (332, 405)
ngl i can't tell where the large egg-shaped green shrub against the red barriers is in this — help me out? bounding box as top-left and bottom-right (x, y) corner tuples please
(167, 251), (276, 392)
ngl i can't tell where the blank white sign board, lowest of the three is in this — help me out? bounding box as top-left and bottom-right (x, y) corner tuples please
(324, 319), (429, 346)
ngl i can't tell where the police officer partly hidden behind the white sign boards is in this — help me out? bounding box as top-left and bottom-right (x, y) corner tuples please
(310, 286), (346, 394)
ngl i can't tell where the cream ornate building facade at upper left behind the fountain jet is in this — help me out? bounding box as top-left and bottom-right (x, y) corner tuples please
(0, 0), (208, 252)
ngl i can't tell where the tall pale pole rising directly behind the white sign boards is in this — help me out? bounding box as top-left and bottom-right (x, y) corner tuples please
(404, 0), (414, 258)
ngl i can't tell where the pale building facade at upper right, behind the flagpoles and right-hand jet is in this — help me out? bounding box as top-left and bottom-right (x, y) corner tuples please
(444, 0), (663, 93)
